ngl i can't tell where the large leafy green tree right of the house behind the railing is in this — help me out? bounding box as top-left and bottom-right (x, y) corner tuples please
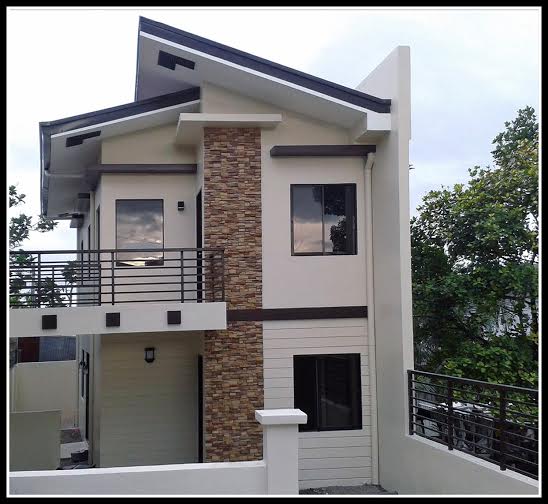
(411, 107), (539, 386)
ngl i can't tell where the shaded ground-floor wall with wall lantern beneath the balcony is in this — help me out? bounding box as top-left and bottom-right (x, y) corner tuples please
(100, 332), (201, 467)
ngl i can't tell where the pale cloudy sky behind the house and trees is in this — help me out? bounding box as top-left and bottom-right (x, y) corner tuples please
(6, 8), (540, 250)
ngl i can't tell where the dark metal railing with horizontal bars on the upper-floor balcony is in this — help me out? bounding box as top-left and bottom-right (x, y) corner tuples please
(9, 248), (225, 308)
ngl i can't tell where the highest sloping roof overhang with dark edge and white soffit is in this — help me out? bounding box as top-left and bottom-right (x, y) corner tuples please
(135, 17), (390, 128)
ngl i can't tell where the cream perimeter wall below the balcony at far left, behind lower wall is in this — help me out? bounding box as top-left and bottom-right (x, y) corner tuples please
(10, 361), (78, 429)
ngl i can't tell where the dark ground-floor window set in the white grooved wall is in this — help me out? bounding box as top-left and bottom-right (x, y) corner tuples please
(293, 354), (362, 432)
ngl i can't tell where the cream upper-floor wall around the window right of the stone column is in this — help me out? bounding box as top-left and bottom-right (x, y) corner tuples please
(202, 84), (367, 308)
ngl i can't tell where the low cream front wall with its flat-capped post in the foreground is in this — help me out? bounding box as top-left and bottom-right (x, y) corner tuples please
(9, 409), (306, 495)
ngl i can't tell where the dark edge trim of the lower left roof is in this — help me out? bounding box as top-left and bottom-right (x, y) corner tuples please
(39, 87), (200, 215)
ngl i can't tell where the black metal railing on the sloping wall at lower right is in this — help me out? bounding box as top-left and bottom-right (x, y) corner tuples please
(407, 370), (539, 479)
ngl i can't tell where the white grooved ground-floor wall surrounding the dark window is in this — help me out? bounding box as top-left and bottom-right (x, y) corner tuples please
(263, 319), (372, 488)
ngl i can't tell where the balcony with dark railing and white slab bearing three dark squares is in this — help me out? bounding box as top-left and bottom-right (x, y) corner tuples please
(9, 248), (226, 337)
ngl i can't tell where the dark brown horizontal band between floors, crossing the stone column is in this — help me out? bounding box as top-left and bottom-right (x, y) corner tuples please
(226, 306), (367, 322)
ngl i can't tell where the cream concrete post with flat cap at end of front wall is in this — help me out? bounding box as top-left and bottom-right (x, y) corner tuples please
(255, 409), (307, 495)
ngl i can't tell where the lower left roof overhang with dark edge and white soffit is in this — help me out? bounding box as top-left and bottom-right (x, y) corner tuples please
(40, 88), (200, 218)
